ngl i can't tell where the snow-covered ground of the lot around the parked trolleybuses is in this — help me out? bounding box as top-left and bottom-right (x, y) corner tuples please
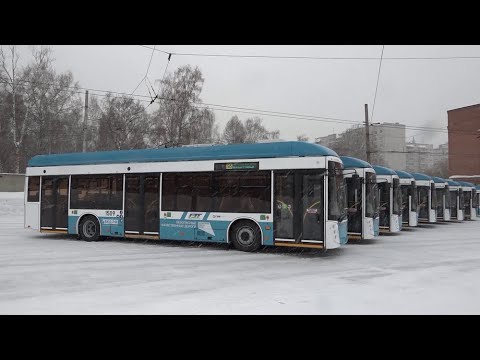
(0, 193), (480, 314)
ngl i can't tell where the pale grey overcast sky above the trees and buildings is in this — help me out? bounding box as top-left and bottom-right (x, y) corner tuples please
(12, 45), (480, 145)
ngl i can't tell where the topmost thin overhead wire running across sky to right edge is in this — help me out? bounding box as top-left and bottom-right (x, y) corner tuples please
(139, 45), (480, 60)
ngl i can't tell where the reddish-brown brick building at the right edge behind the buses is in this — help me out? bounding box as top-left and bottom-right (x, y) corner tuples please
(447, 104), (480, 184)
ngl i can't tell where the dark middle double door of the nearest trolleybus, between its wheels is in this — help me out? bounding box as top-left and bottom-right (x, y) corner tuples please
(125, 174), (160, 235)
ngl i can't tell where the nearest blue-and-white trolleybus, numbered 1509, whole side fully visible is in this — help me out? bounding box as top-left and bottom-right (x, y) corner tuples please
(25, 141), (347, 251)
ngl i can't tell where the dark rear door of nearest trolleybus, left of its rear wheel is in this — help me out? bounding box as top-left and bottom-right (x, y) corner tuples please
(40, 176), (68, 230)
